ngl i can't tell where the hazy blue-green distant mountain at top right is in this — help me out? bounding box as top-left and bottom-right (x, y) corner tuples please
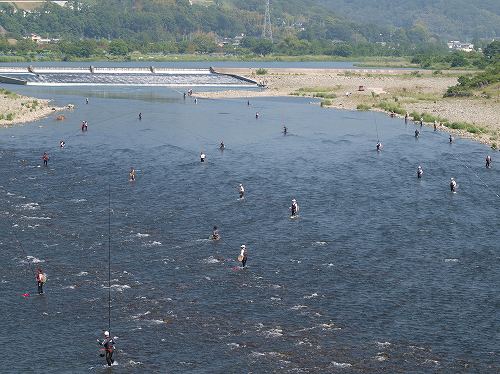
(317, 0), (500, 39)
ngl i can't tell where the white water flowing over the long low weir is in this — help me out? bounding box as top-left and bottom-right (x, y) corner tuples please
(0, 66), (257, 87)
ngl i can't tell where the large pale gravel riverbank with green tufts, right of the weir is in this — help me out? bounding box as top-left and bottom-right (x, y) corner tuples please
(195, 68), (500, 148)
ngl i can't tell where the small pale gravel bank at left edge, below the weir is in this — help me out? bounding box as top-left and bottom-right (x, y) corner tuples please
(0, 89), (64, 127)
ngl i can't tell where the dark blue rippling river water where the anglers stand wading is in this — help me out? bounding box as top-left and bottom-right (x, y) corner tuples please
(0, 87), (500, 373)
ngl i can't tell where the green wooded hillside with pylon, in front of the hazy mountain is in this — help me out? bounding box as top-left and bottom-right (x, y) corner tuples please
(0, 0), (496, 60)
